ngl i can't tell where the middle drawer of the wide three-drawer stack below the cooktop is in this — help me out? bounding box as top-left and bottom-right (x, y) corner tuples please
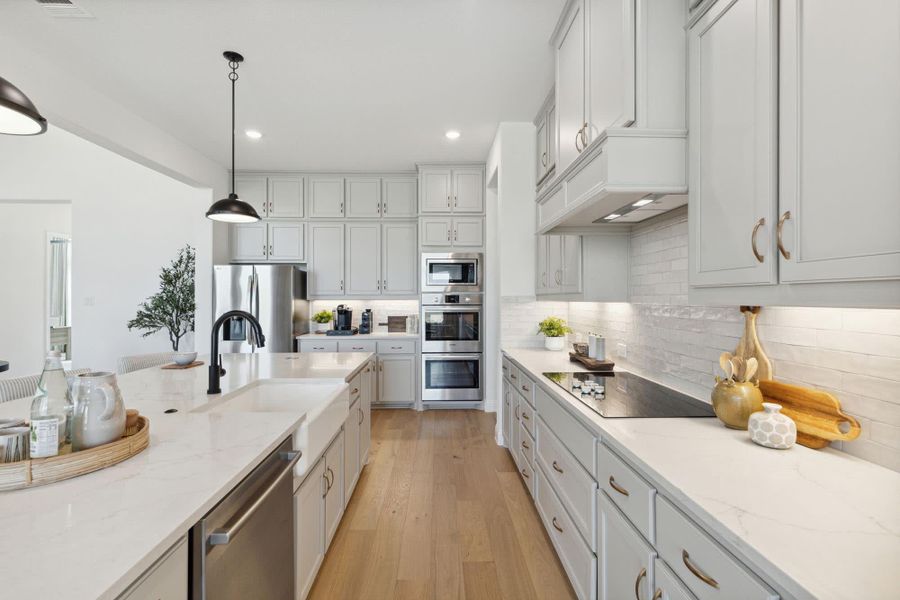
(537, 415), (597, 551)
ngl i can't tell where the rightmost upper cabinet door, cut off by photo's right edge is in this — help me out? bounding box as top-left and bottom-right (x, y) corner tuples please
(779, 0), (900, 282)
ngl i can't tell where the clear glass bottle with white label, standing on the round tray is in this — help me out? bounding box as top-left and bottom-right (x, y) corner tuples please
(29, 351), (72, 458)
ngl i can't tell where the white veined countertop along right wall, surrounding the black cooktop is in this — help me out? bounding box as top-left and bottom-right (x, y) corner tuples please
(503, 349), (900, 600)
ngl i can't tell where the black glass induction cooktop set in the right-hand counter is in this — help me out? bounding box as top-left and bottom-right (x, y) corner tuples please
(544, 371), (716, 419)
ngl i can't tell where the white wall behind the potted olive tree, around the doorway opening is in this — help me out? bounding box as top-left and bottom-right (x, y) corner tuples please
(0, 127), (213, 376)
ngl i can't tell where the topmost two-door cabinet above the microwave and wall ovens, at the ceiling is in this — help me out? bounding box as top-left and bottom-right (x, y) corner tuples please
(419, 166), (484, 213)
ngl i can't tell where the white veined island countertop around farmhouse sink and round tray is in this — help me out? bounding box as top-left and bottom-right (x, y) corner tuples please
(0, 352), (372, 599)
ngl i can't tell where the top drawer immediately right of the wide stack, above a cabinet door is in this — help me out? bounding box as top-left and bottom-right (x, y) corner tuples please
(597, 444), (656, 543)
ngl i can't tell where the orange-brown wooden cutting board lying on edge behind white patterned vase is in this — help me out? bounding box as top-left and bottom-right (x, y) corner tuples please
(759, 380), (860, 449)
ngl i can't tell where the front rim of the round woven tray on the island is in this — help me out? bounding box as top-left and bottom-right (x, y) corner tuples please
(0, 416), (150, 491)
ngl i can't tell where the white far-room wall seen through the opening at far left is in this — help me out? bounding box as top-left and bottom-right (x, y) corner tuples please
(0, 202), (72, 370)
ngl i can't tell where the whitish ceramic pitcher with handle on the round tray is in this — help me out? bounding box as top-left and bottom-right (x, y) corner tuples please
(72, 372), (125, 452)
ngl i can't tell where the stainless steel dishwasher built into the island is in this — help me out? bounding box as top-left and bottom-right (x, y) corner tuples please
(190, 438), (301, 600)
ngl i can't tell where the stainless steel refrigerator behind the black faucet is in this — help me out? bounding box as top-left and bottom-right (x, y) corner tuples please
(213, 265), (309, 353)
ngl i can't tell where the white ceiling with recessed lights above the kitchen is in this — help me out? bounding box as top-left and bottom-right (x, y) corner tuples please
(0, 0), (564, 170)
